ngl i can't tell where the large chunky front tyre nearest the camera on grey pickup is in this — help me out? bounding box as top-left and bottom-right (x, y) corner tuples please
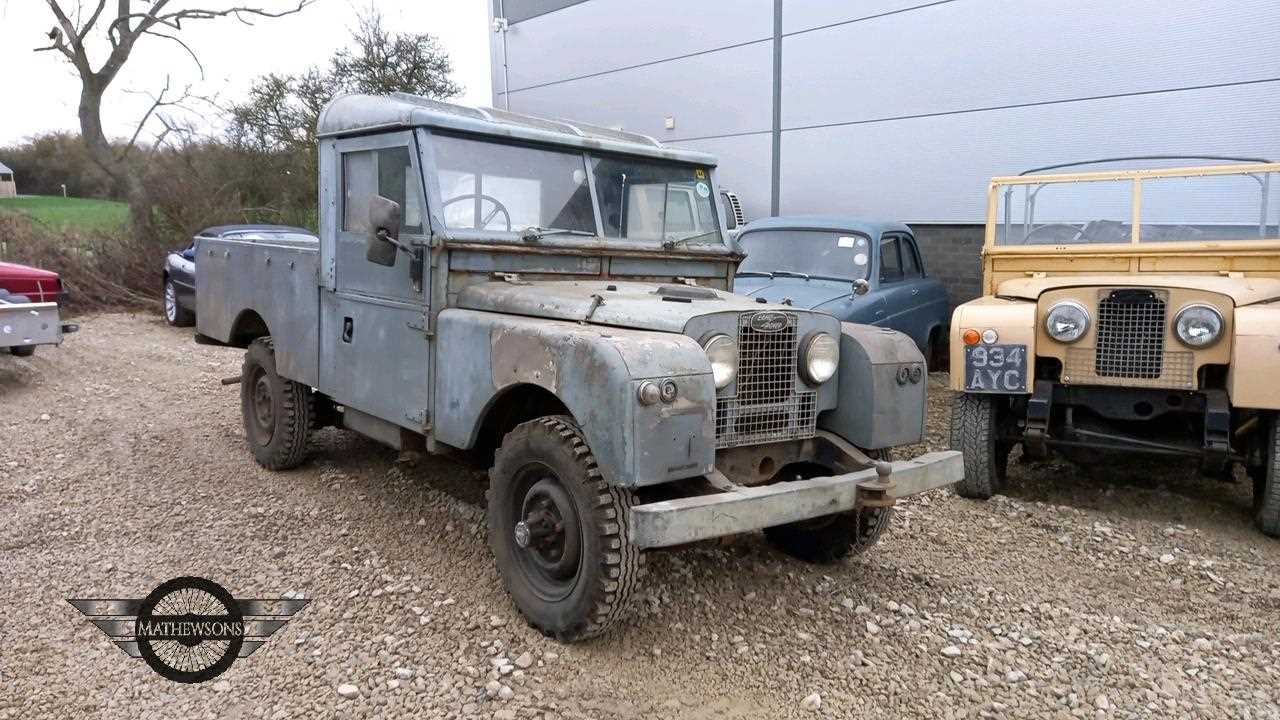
(486, 415), (644, 642)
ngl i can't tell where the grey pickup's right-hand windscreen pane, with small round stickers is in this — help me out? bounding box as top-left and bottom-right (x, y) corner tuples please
(591, 156), (724, 245)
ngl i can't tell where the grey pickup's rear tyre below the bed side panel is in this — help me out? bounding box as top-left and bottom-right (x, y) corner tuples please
(241, 337), (315, 470)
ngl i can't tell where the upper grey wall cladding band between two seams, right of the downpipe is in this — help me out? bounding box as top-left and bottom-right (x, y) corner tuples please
(782, 0), (1280, 126)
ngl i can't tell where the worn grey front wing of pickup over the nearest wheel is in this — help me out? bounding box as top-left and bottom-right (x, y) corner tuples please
(433, 310), (716, 487)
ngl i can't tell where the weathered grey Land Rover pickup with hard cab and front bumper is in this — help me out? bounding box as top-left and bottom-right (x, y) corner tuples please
(196, 95), (963, 641)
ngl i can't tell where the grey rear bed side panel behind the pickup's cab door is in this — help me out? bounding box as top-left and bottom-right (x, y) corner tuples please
(196, 237), (320, 387)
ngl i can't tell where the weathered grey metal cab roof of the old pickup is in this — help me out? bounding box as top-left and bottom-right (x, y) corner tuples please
(316, 92), (717, 167)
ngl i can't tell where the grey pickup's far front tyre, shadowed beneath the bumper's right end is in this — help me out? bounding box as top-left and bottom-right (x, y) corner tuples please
(764, 507), (893, 565)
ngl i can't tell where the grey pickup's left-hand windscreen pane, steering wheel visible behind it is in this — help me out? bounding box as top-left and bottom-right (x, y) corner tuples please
(433, 133), (595, 234)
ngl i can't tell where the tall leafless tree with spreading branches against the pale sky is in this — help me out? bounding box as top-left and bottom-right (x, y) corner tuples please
(36, 0), (312, 231)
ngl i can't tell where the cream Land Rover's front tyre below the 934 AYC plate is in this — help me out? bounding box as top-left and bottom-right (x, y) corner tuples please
(951, 393), (1011, 500)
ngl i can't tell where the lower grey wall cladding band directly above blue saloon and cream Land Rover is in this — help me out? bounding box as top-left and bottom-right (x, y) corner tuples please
(778, 83), (1280, 220)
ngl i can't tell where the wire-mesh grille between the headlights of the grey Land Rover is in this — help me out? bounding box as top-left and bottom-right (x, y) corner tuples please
(716, 310), (818, 447)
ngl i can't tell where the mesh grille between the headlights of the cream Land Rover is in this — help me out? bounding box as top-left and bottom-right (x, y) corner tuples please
(1062, 288), (1196, 388)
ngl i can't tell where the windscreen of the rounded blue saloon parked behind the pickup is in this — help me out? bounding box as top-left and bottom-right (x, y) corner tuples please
(737, 229), (870, 281)
